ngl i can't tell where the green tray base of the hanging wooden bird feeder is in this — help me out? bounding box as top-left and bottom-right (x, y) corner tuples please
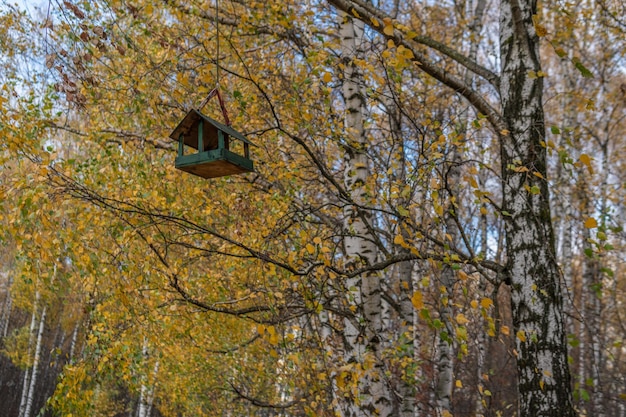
(176, 149), (254, 178)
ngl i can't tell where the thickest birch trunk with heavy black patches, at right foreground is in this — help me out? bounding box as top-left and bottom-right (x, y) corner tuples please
(500, 0), (575, 417)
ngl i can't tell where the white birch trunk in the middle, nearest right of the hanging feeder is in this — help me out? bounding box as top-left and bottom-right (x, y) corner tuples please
(340, 8), (392, 417)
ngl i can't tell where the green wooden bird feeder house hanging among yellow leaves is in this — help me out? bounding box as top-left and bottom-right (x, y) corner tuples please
(170, 109), (254, 178)
